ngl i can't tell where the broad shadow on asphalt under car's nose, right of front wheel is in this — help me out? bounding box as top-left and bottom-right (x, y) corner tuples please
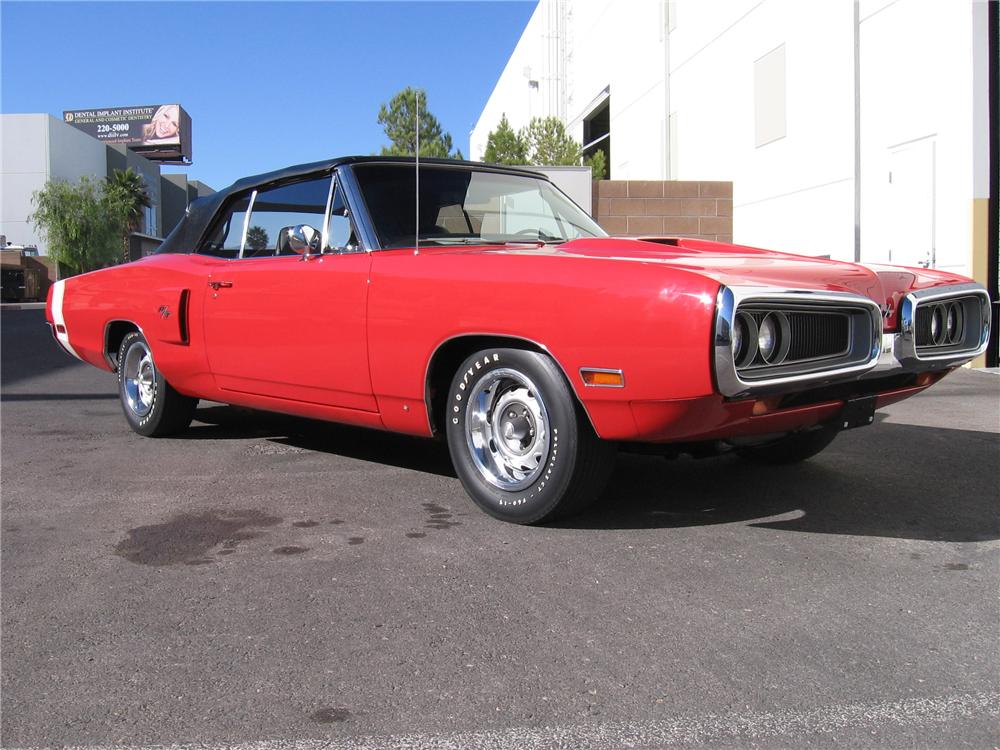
(558, 423), (1000, 542)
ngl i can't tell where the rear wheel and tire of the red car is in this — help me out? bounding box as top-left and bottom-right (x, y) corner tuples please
(118, 331), (198, 437)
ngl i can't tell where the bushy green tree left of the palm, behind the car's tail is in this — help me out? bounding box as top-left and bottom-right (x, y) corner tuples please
(28, 177), (128, 274)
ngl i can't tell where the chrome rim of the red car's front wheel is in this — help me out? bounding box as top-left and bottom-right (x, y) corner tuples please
(465, 368), (549, 492)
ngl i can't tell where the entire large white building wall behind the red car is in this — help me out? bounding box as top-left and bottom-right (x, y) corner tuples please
(469, 0), (987, 274)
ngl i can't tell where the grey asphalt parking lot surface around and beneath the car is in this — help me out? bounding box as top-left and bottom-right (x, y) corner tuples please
(0, 311), (1000, 750)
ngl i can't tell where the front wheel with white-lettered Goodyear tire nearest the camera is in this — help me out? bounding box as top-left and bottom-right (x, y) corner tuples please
(445, 349), (615, 524)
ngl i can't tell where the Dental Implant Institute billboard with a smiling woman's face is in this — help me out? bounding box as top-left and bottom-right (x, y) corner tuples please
(63, 104), (191, 164)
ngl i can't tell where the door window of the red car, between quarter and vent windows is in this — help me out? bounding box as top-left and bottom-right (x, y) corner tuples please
(243, 175), (331, 258)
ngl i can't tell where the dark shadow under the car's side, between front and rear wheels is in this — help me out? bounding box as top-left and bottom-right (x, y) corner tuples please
(188, 405), (455, 477)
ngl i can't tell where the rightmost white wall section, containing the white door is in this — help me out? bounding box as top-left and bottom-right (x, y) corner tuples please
(861, 0), (976, 274)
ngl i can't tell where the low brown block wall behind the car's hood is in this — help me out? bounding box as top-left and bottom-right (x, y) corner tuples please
(594, 180), (733, 242)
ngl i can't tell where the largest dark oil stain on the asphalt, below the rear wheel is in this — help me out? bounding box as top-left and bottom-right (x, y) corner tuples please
(114, 510), (281, 565)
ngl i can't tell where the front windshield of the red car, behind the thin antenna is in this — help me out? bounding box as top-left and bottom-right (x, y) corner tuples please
(354, 164), (607, 248)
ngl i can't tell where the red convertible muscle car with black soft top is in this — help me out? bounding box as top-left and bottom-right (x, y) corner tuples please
(47, 157), (989, 523)
